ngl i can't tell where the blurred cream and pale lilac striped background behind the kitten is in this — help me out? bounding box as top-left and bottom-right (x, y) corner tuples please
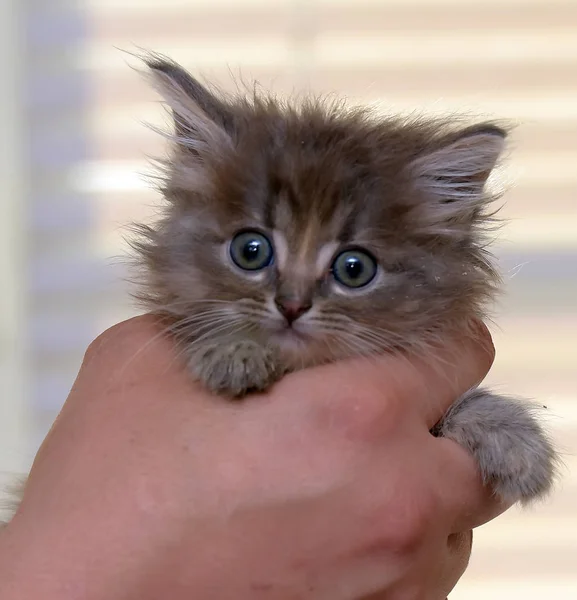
(0, 0), (577, 600)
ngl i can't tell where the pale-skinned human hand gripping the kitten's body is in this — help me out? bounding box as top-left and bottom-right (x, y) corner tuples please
(0, 316), (506, 600)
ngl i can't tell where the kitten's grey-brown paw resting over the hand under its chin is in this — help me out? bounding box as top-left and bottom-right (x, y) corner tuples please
(189, 341), (283, 397)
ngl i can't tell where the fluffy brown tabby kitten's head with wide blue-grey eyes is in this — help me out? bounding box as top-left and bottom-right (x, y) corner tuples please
(137, 58), (505, 365)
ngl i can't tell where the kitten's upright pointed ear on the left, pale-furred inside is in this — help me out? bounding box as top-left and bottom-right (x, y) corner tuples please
(145, 55), (234, 150)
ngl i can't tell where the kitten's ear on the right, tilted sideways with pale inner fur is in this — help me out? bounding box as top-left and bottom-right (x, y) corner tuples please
(411, 124), (507, 204)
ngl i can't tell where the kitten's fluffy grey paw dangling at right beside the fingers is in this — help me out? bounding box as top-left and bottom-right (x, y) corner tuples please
(433, 389), (558, 504)
